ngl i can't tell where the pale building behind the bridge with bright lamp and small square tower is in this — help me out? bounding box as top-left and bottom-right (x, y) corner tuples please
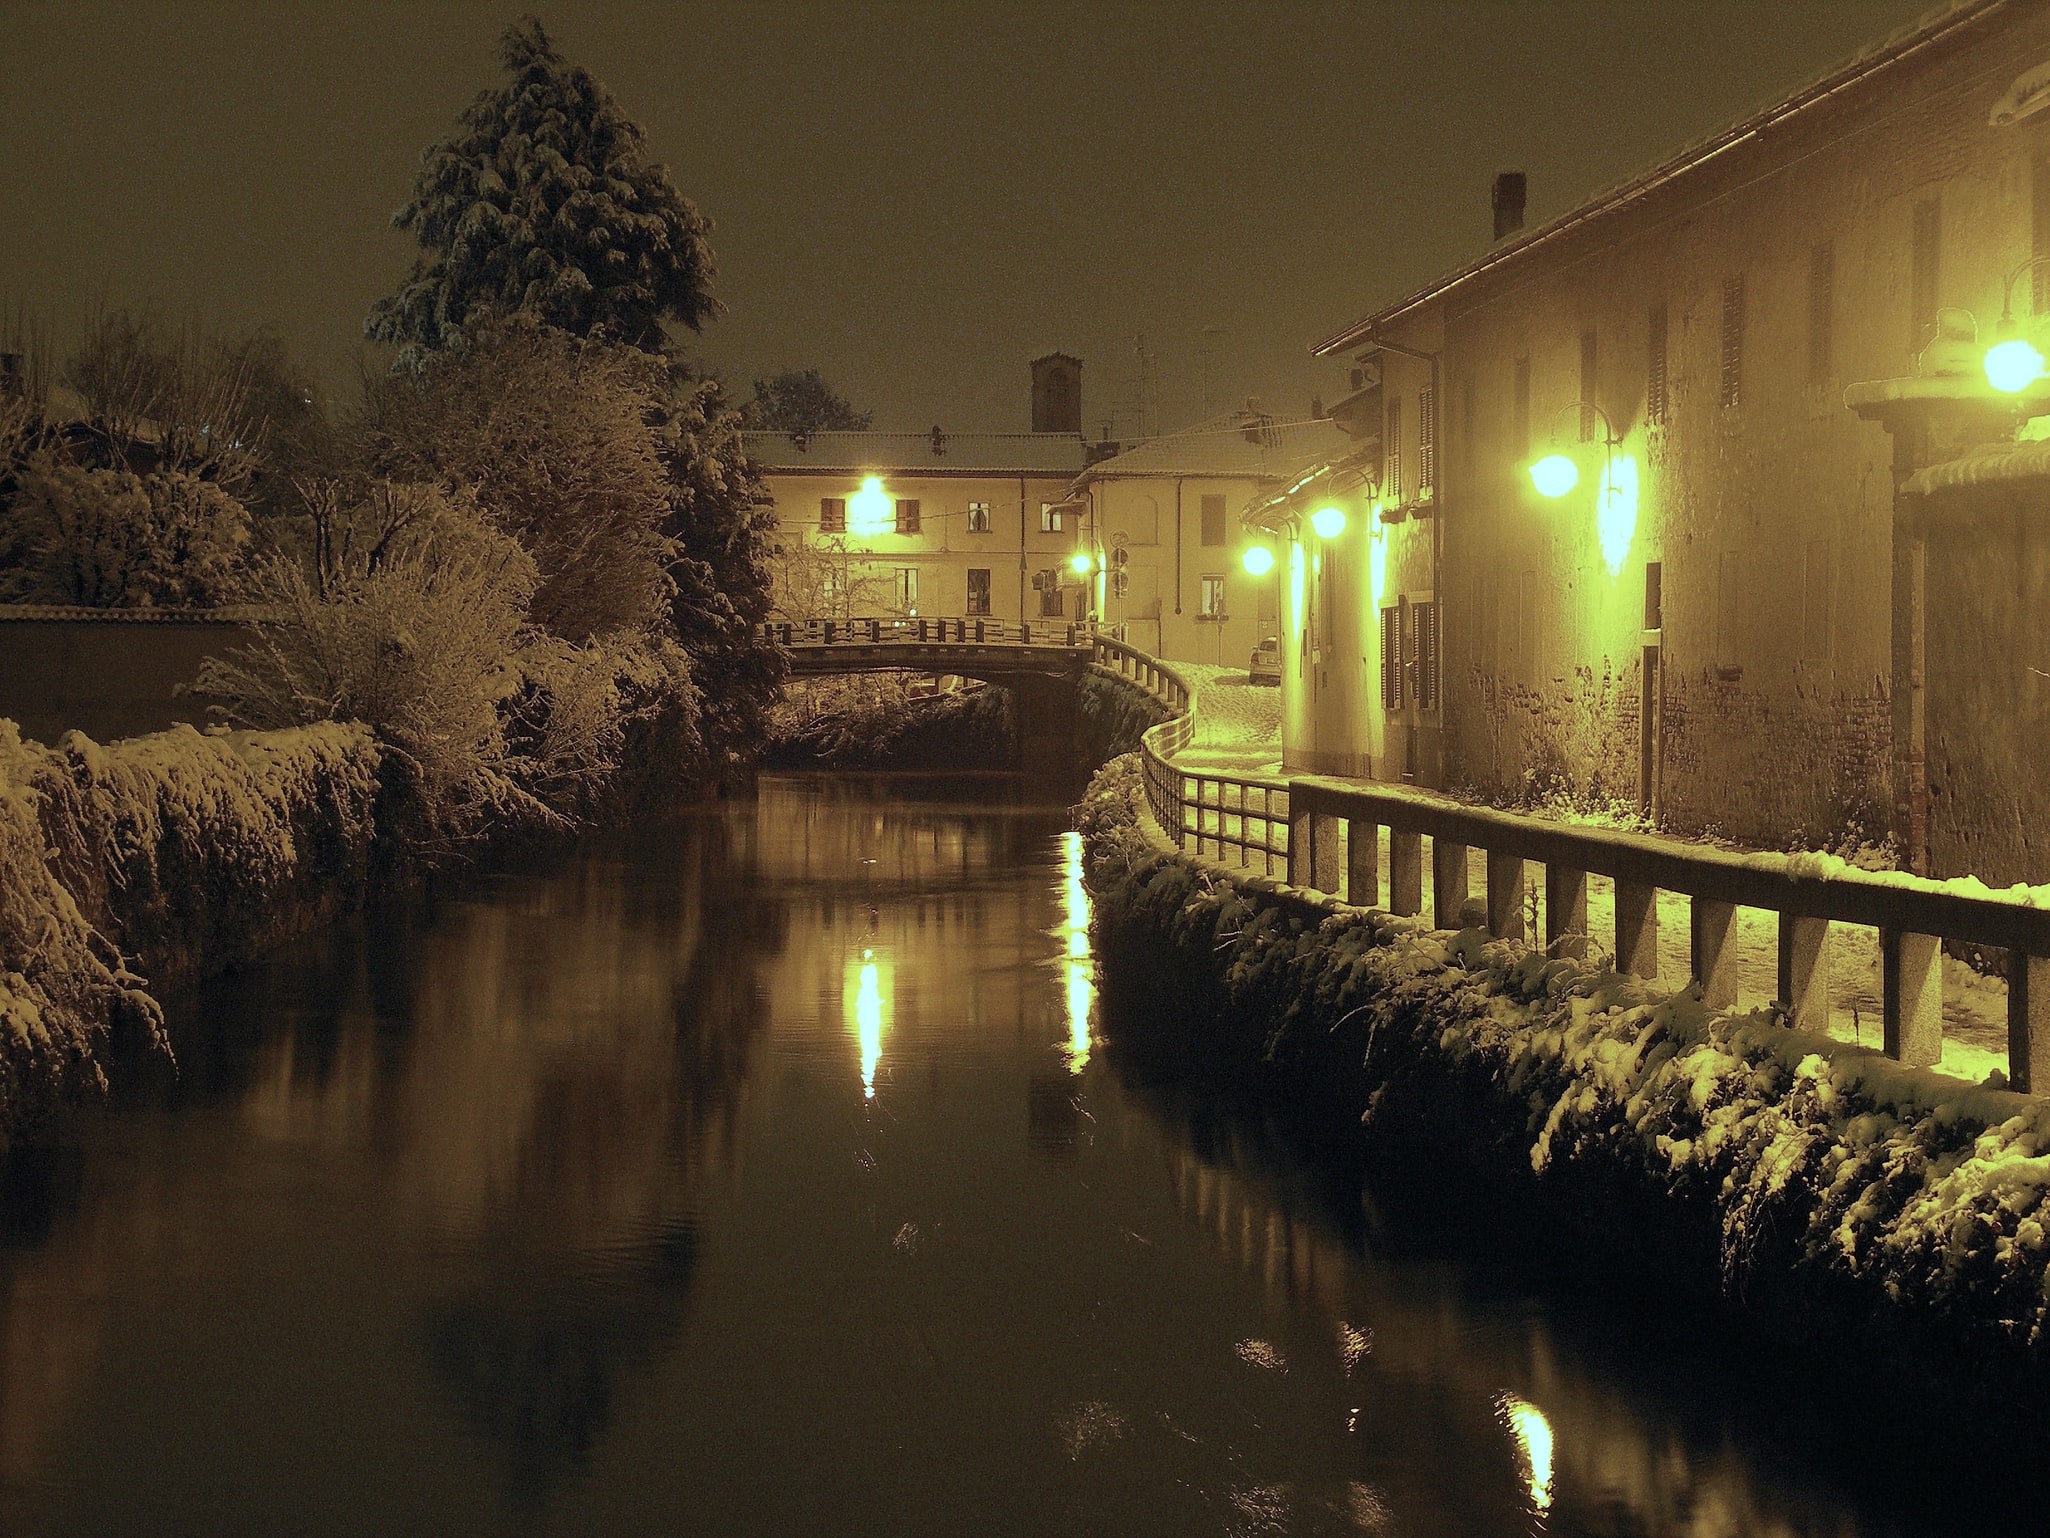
(744, 353), (1093, 621)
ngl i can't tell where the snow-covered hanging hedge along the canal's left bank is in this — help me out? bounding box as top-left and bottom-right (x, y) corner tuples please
(0, 720), (387, 1144)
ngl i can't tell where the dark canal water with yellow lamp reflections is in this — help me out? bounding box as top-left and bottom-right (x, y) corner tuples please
(0, 777), (2019, 1538)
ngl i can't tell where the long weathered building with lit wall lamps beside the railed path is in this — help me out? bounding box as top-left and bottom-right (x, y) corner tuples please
(1287, 0), (2050, 880)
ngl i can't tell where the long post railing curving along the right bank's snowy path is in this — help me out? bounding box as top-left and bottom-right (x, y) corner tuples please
(1095, 638), (2050, 1091)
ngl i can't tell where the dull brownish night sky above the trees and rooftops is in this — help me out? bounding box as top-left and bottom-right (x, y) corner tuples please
(0, 0), (1929, 437)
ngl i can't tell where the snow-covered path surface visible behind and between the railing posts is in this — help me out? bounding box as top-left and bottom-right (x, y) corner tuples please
(1175, 680), (2007, 1081)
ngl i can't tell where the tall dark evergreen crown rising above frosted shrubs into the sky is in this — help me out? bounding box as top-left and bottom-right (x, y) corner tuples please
(367, 16), (720, 359)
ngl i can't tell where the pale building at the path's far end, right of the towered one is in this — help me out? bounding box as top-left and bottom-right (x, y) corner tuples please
(1072, 404), (1347, 666)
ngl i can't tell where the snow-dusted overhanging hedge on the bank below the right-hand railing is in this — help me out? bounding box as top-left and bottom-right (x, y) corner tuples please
(1080, 759), (2050, 1429)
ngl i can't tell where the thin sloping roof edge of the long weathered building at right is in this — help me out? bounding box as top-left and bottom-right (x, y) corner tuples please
(1310, 0), (2011, 357)
